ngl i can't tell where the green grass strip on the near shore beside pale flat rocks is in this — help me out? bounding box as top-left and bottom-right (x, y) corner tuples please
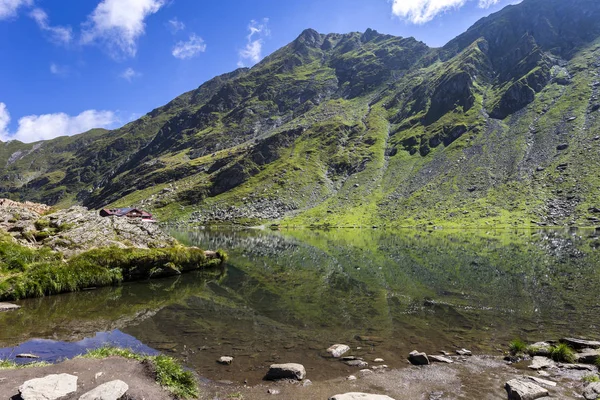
(83, 347), (199, 399)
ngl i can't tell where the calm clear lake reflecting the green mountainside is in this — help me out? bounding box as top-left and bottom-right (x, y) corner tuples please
(0, 230), (600, 383)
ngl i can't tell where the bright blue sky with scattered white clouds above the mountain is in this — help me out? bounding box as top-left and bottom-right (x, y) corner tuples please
(0, 0), (518, 142)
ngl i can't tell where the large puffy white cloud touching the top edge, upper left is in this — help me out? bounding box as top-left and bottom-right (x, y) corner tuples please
(81, 0), (166, 58)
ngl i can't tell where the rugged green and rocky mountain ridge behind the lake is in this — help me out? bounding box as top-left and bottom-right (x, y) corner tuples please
(0, 0), (600, 226)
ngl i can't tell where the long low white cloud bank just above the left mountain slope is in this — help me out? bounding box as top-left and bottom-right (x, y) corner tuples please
(0, 103), (119, 143)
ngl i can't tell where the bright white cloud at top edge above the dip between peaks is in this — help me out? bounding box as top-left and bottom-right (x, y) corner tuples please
(392, 0), (500, 24)
